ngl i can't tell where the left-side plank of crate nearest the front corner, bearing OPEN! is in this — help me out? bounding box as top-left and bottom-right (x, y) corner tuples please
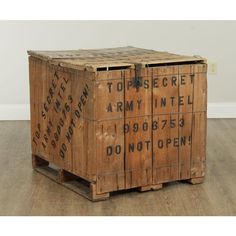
(65, 71), (96, 180)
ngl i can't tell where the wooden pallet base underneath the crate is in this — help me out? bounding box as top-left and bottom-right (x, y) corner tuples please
(32, 155), (204, 201)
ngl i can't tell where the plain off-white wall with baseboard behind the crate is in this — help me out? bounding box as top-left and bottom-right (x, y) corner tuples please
(0, 21), (236, 119)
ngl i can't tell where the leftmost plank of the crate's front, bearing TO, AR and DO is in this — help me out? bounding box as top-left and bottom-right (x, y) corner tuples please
(94, 70), (125, 194)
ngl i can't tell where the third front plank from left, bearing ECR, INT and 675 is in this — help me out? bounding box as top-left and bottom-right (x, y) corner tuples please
(152, 66), (179, 184)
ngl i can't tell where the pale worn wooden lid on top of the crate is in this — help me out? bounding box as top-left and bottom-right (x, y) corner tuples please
(28, 46), (205, 71)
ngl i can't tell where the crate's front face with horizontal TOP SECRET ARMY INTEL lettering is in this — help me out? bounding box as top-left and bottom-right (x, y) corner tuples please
(96, 64), (206, 192)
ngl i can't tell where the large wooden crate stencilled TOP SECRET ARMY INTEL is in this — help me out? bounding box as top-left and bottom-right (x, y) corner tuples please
(28, 47), (207, 200)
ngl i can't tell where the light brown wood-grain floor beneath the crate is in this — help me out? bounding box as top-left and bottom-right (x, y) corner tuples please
(0, 119), (236, 215)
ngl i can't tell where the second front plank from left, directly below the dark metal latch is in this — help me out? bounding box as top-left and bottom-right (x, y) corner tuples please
(124, 67), (152, 188)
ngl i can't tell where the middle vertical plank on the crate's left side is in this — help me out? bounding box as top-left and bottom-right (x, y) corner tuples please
(44, 66), (71, 170)
